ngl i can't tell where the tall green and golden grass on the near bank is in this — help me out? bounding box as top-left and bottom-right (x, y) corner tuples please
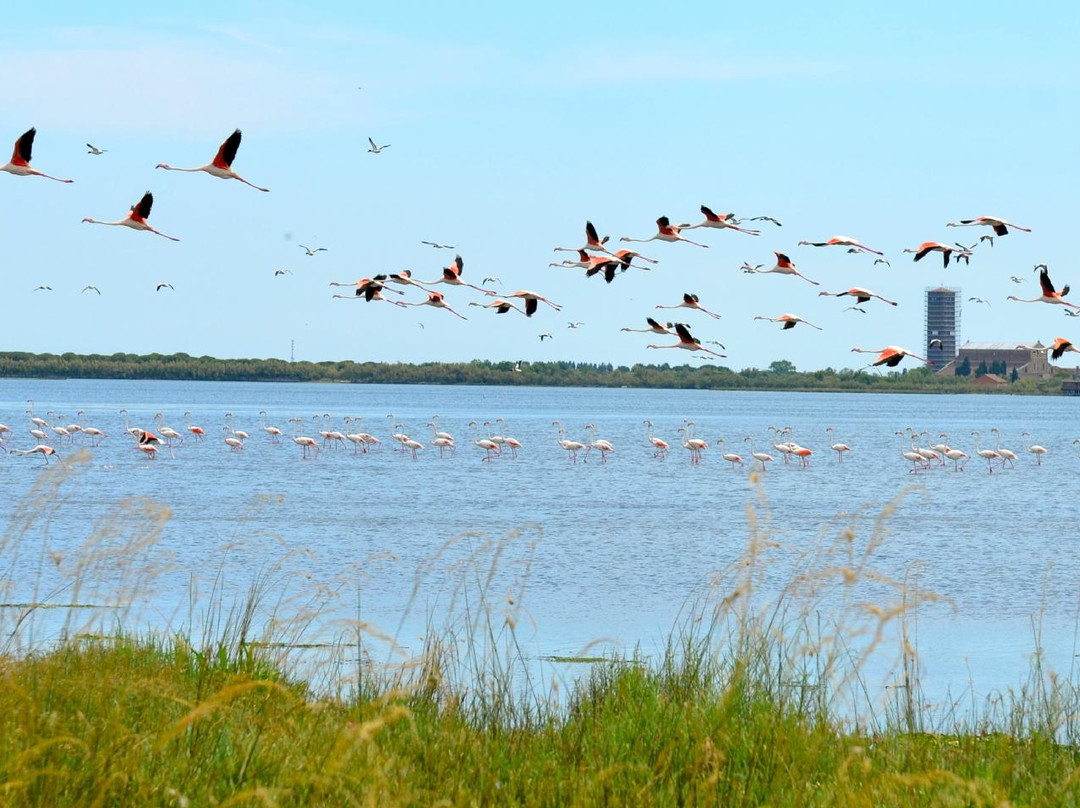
(0, 458), (1080, 806)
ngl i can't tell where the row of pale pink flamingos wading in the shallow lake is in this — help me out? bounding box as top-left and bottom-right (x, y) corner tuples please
(0, 399), (1062, 473)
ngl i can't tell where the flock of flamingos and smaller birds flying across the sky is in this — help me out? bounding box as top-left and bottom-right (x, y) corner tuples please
(8, 123), (1080, 367)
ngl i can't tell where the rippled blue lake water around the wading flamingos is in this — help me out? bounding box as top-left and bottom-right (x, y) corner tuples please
(0, 379), (1080, 717)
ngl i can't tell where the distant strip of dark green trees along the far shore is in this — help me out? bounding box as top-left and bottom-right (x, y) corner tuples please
(0, 352), (1075, 395)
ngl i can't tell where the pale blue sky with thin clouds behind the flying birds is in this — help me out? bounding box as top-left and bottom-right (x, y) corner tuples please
(0, 2), (1080, 369)
